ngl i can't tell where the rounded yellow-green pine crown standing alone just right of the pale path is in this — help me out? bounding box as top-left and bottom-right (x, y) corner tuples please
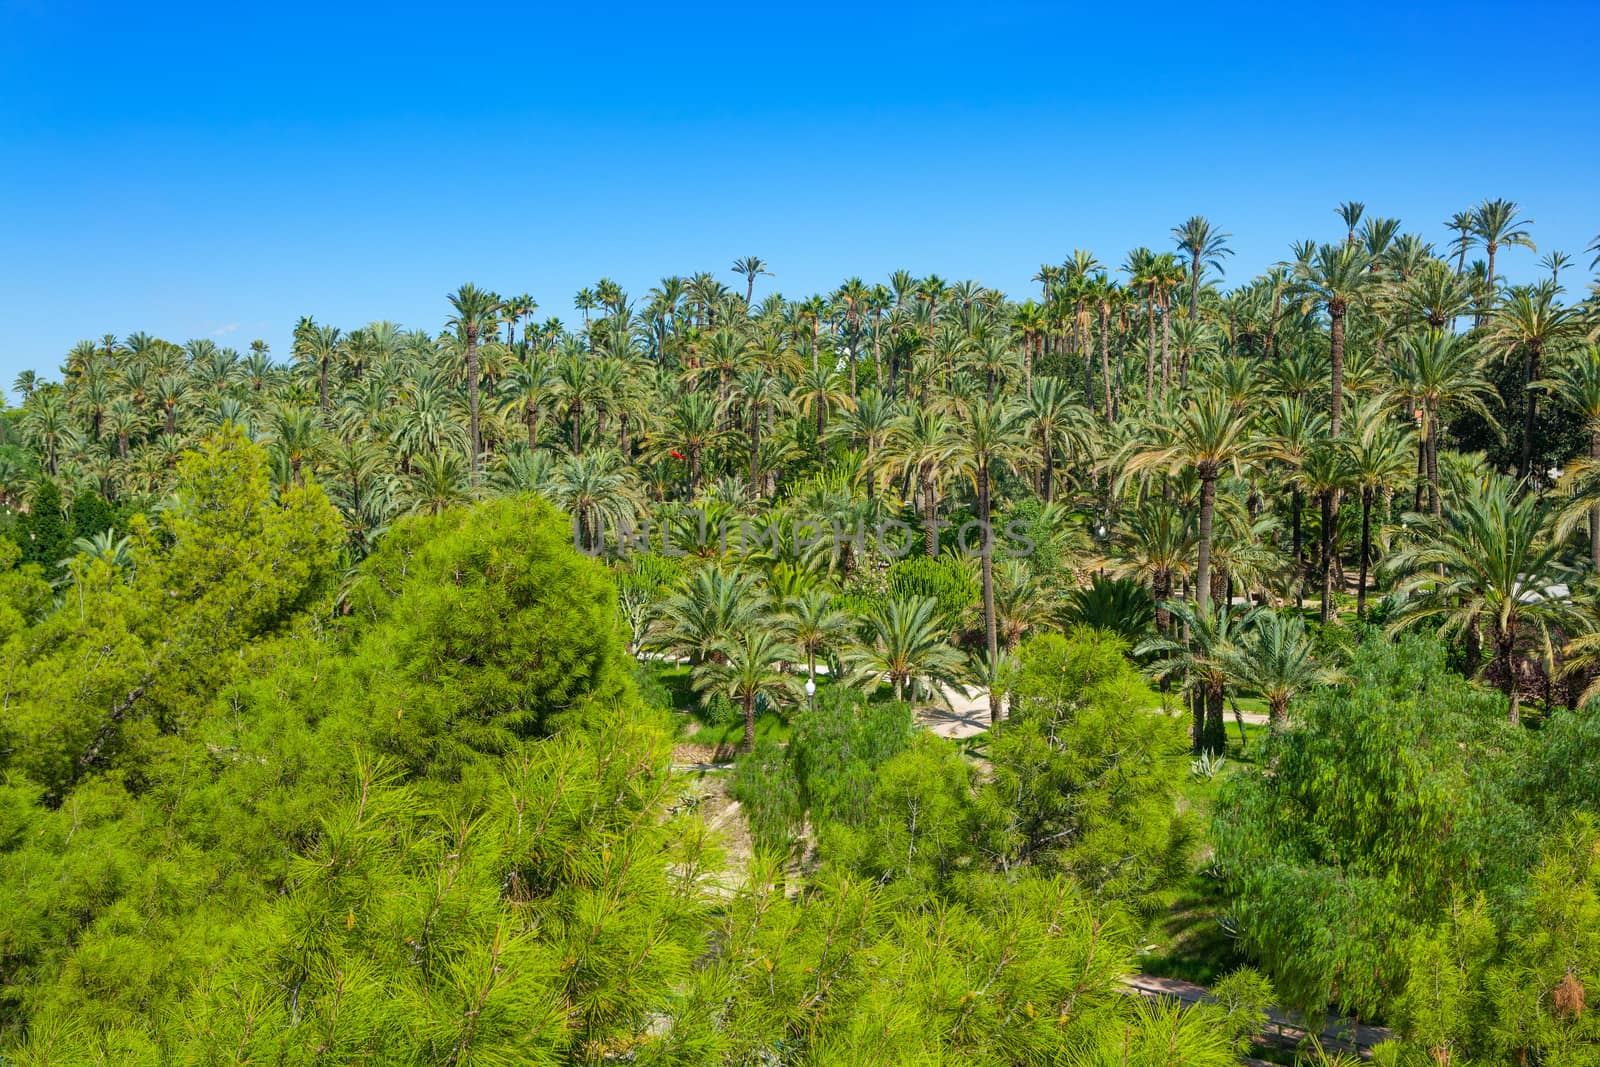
(982, 627), (1192, 899)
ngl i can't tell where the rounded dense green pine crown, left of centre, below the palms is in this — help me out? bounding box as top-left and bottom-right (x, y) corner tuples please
(349, 496), (646, 773)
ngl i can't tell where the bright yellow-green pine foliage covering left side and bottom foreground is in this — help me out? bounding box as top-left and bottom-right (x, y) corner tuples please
(0, 430), (1238, 1067)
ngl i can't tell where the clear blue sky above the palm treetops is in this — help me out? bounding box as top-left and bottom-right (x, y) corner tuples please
(0, 0), (1600, 386)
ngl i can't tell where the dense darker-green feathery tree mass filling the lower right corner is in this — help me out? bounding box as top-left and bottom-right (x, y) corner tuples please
(1214, 637), (1600, 1064)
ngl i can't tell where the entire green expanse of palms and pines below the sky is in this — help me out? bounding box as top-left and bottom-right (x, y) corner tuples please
(0, 200), (1600, 1064)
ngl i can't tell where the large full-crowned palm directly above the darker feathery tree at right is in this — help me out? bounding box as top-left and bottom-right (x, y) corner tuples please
(1386, 474), (1582, 723)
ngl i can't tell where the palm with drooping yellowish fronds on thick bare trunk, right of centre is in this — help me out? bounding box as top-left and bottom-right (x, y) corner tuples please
(1122, 389), (1267, 609)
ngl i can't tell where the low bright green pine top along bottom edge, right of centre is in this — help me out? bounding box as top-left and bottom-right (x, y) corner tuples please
(690, 872), (1235, 1067)
